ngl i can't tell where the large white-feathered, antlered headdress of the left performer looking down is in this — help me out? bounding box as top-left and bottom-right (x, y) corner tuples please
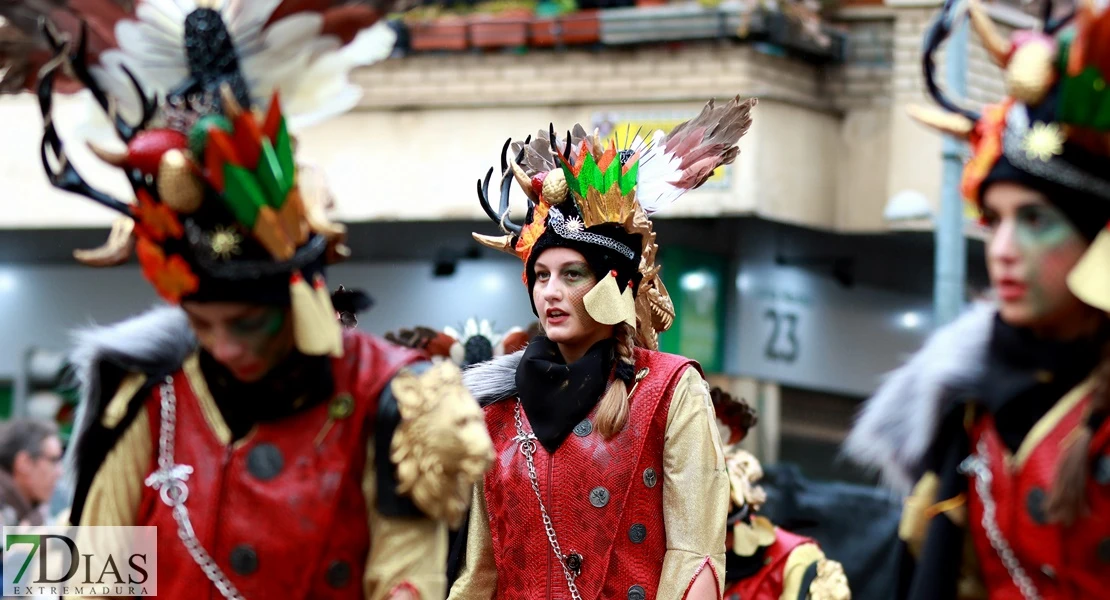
(27, 0), (404, 355)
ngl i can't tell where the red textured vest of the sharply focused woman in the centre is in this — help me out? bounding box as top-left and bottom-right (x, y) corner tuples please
(485, 348), (696, 600)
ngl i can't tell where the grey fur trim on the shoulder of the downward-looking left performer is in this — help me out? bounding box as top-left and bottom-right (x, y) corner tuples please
(65, 306), (196, 485)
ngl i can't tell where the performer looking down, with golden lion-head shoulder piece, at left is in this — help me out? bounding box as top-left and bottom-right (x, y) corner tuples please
(23, 0), (493, 599)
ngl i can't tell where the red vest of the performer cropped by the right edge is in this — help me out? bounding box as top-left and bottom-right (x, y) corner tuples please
(968, 385), (1110, 600)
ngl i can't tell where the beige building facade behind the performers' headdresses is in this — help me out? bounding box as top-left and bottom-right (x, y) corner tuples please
(0, 0), (1029, 232)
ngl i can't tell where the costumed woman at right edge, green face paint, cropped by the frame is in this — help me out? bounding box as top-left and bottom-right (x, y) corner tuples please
(846, 0), (1110, 600)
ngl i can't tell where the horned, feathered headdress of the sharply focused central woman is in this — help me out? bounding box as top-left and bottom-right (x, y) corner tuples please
(474, 96), (756, 349)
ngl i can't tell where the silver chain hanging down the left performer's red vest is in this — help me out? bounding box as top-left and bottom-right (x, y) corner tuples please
(145, 377), (244, 600)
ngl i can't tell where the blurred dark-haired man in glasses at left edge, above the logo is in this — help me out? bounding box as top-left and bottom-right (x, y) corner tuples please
(0, 419), (62, 526)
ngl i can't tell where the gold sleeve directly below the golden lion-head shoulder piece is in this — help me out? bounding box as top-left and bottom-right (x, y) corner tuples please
(362, 439), (447, 600)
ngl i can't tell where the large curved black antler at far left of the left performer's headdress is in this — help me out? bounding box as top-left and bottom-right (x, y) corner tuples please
(38, 24), (134, 216)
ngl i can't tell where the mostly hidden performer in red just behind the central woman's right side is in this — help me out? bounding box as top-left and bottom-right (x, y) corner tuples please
(710, 387), (851, 600)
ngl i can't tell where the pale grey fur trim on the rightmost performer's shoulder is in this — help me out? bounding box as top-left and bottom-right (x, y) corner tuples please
(842, 303), (996, 494)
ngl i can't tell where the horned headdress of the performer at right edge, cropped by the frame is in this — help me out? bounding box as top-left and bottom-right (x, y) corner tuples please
(910, 0), (1110, 311)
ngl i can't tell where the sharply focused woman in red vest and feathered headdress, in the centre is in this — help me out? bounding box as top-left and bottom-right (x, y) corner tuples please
(451, 98), (755, 600)
